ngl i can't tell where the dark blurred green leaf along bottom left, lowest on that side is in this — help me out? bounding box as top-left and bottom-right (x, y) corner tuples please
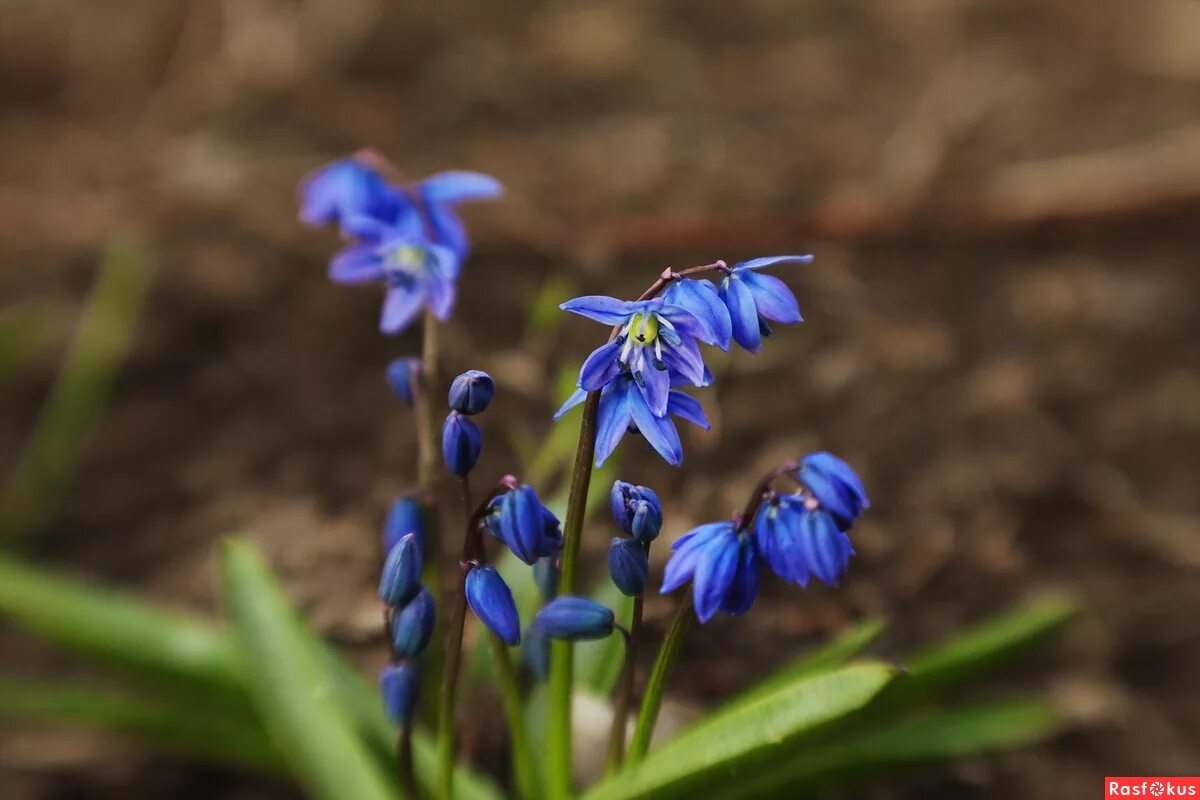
(0, 678), (284, 774)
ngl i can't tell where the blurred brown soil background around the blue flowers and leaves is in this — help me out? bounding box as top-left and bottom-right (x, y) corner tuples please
(0, 0), (1200, 799)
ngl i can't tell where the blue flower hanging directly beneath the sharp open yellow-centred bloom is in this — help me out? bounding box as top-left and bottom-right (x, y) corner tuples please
(554, 372), (709, 467)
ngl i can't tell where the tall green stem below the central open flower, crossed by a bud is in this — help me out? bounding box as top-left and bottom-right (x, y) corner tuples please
(546, 391), (600, 800)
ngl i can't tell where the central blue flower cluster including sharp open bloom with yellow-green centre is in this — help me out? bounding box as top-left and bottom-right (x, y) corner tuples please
(554, 255), (812, 467)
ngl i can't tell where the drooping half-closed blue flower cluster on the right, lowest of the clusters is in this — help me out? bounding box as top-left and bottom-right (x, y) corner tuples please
(661, 452), (870, 622)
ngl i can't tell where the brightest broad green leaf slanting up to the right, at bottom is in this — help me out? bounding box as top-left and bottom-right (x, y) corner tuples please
(584, 662), (893, 800)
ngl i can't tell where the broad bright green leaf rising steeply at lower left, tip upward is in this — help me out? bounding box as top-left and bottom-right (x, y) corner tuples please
(222, 540), (397, 800)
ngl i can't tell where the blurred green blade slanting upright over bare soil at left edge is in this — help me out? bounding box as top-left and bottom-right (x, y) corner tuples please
(0, 237), (154, 545)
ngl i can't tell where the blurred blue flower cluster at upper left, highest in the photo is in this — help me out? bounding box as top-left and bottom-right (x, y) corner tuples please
(300, 155), (503, 333)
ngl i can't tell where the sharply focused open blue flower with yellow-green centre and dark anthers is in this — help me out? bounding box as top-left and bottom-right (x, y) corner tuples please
(559, 295), (716, 417)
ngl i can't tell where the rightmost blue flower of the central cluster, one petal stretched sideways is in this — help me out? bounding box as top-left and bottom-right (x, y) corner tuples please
(721, 255), (812, 353)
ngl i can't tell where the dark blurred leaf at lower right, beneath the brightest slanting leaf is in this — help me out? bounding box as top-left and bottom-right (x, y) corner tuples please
(721, 700), (1062, 800)
